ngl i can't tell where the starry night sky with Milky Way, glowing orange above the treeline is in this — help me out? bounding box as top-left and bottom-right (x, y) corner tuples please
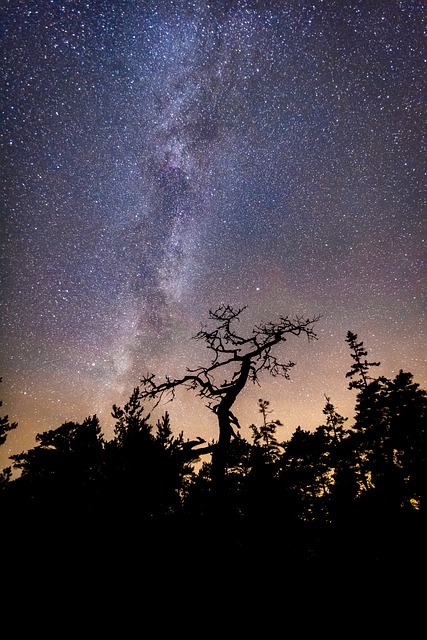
(0, 0), (427, 467)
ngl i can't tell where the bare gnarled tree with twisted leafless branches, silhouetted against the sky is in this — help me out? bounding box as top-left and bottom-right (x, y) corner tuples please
(140, 305), (319, 495)
